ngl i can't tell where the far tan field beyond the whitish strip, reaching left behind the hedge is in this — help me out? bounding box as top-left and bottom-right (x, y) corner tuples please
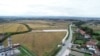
(16, 20), (70, 30)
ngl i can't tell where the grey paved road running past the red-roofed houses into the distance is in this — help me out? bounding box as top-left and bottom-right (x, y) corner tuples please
(56, 25), (72, 56)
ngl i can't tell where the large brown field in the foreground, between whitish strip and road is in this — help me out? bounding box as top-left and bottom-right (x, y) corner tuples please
(12, 32), (66, 56)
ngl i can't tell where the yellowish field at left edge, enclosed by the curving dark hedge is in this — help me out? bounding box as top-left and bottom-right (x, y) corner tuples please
(0, 23), (28, 33)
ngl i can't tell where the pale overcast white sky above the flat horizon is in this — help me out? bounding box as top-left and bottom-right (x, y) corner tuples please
(0, 0), (100, 17)
